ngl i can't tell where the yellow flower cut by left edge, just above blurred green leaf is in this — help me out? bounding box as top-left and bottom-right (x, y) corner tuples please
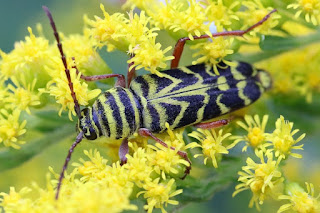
(0, 109), (27, 149)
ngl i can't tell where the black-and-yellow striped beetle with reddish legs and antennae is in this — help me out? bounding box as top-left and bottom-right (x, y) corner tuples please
(43, 6), (276, 199)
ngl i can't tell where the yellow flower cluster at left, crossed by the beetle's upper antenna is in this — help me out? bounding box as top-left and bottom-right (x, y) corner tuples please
(0, 24), (111, 146)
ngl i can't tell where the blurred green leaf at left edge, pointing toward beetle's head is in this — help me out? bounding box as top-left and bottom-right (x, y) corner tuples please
(0, 124), (74, 172)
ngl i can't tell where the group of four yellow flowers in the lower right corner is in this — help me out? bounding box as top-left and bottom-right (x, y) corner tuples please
(231, 115), (320, 213)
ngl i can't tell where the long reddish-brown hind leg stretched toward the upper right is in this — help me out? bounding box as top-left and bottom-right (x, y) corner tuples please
(171, 9), (277, 69)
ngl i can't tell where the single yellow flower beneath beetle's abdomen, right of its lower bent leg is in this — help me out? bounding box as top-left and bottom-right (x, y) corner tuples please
(186, 129), (233, 168)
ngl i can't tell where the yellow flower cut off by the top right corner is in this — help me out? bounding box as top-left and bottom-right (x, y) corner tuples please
(287, 0), (320, 25)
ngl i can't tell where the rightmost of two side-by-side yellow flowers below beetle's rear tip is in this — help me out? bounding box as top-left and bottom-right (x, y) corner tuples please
(265, 115), (306, 159)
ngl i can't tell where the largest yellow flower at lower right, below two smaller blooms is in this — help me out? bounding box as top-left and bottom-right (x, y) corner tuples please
(232, 150), (284, 210)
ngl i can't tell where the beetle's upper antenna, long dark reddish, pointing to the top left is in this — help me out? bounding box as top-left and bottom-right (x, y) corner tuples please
(42, 6), (80, 118)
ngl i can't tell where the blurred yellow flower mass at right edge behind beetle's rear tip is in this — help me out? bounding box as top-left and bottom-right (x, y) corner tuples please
(260, 41), (320, 103)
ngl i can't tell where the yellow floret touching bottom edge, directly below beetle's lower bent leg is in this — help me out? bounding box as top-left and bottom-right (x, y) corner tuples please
(137, 178), (182, 213)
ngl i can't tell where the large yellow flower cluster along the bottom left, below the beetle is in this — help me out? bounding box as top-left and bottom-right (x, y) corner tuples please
(0, 133), (189, 213)
